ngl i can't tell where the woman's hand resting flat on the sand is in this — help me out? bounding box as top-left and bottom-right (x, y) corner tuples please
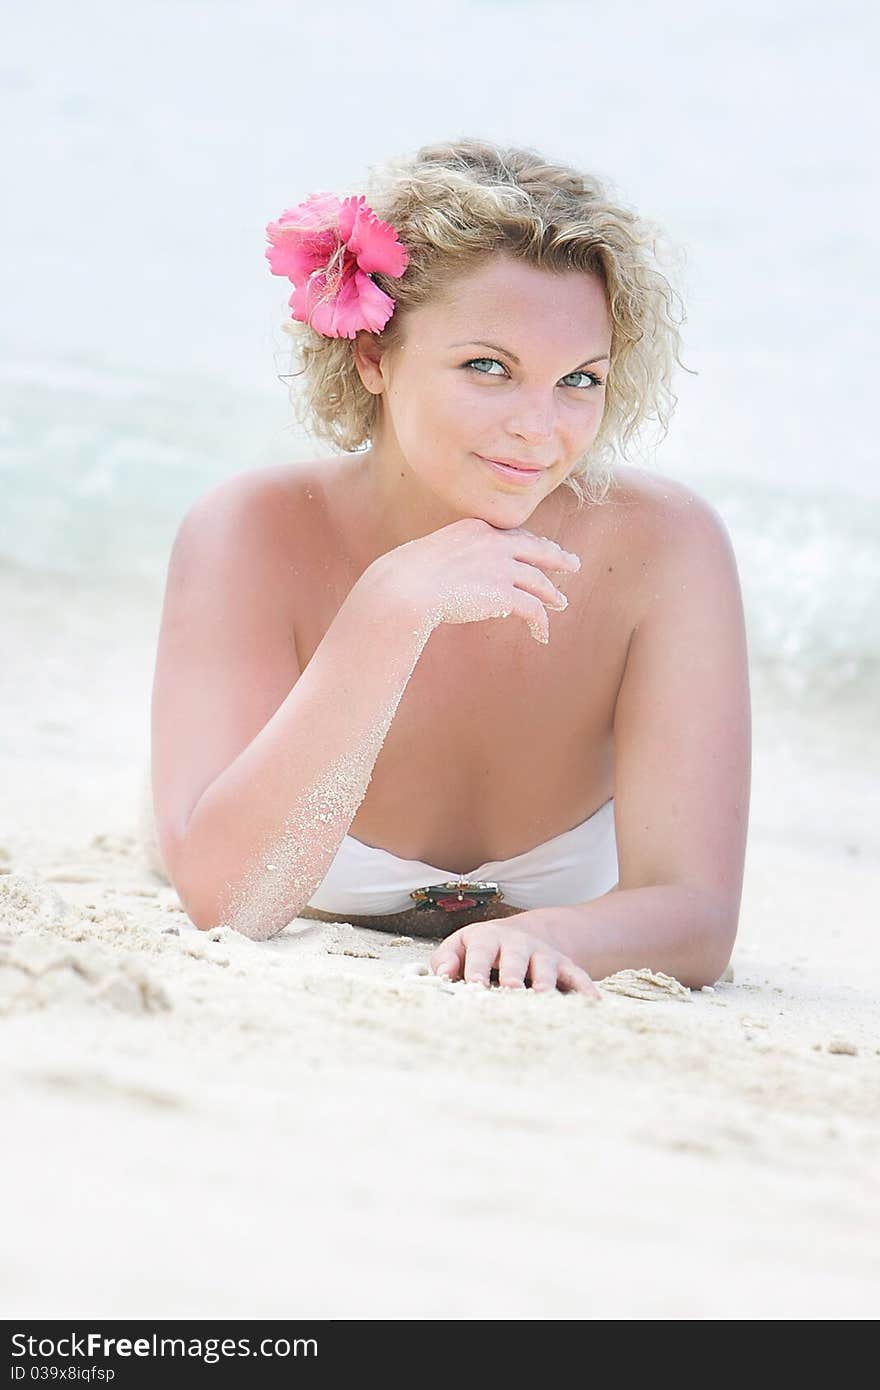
(430, 917), (602, 999)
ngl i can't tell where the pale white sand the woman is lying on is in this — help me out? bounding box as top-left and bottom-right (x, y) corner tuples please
(0, 567), (880, 1319)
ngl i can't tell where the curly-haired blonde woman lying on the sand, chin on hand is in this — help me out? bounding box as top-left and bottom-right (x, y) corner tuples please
(143, 139), (751, 997)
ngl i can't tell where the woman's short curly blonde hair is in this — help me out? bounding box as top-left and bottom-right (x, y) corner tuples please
(281, 138), (690, 506)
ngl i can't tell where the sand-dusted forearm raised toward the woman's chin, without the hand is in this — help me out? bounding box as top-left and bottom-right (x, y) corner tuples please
(181, 575), (431, 940)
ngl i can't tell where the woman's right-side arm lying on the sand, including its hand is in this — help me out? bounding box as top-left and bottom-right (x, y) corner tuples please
(431, 484), (751, 988)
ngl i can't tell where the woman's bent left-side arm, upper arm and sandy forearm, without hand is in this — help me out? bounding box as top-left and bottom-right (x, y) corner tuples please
(153, 480), (432, 940)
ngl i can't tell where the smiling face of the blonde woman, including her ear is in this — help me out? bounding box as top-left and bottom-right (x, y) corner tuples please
(359, 256), (612, 527)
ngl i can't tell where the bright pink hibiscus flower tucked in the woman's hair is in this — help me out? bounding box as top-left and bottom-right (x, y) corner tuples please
(266, 193), (409, 338)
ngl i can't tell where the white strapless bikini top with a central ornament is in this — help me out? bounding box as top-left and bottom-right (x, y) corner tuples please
(309, 796), (619, 917)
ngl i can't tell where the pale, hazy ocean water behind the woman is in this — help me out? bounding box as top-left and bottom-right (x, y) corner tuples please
(0, 0), (880, 712)
